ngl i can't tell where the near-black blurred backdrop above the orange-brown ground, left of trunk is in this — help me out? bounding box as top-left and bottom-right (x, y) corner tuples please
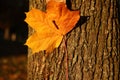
(0, 0), (29, 56)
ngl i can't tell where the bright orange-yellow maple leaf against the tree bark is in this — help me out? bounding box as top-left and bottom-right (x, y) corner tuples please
(25, 0), (80, 53)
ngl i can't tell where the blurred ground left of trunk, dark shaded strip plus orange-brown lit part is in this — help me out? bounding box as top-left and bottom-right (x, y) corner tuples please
(0, 41), (27, 80)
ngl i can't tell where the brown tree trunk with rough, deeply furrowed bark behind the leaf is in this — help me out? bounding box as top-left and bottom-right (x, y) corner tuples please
(27, 0), (120, 80)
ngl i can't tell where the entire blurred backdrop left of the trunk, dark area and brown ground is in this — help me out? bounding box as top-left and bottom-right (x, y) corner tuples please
(0, 0), (29, 80)
